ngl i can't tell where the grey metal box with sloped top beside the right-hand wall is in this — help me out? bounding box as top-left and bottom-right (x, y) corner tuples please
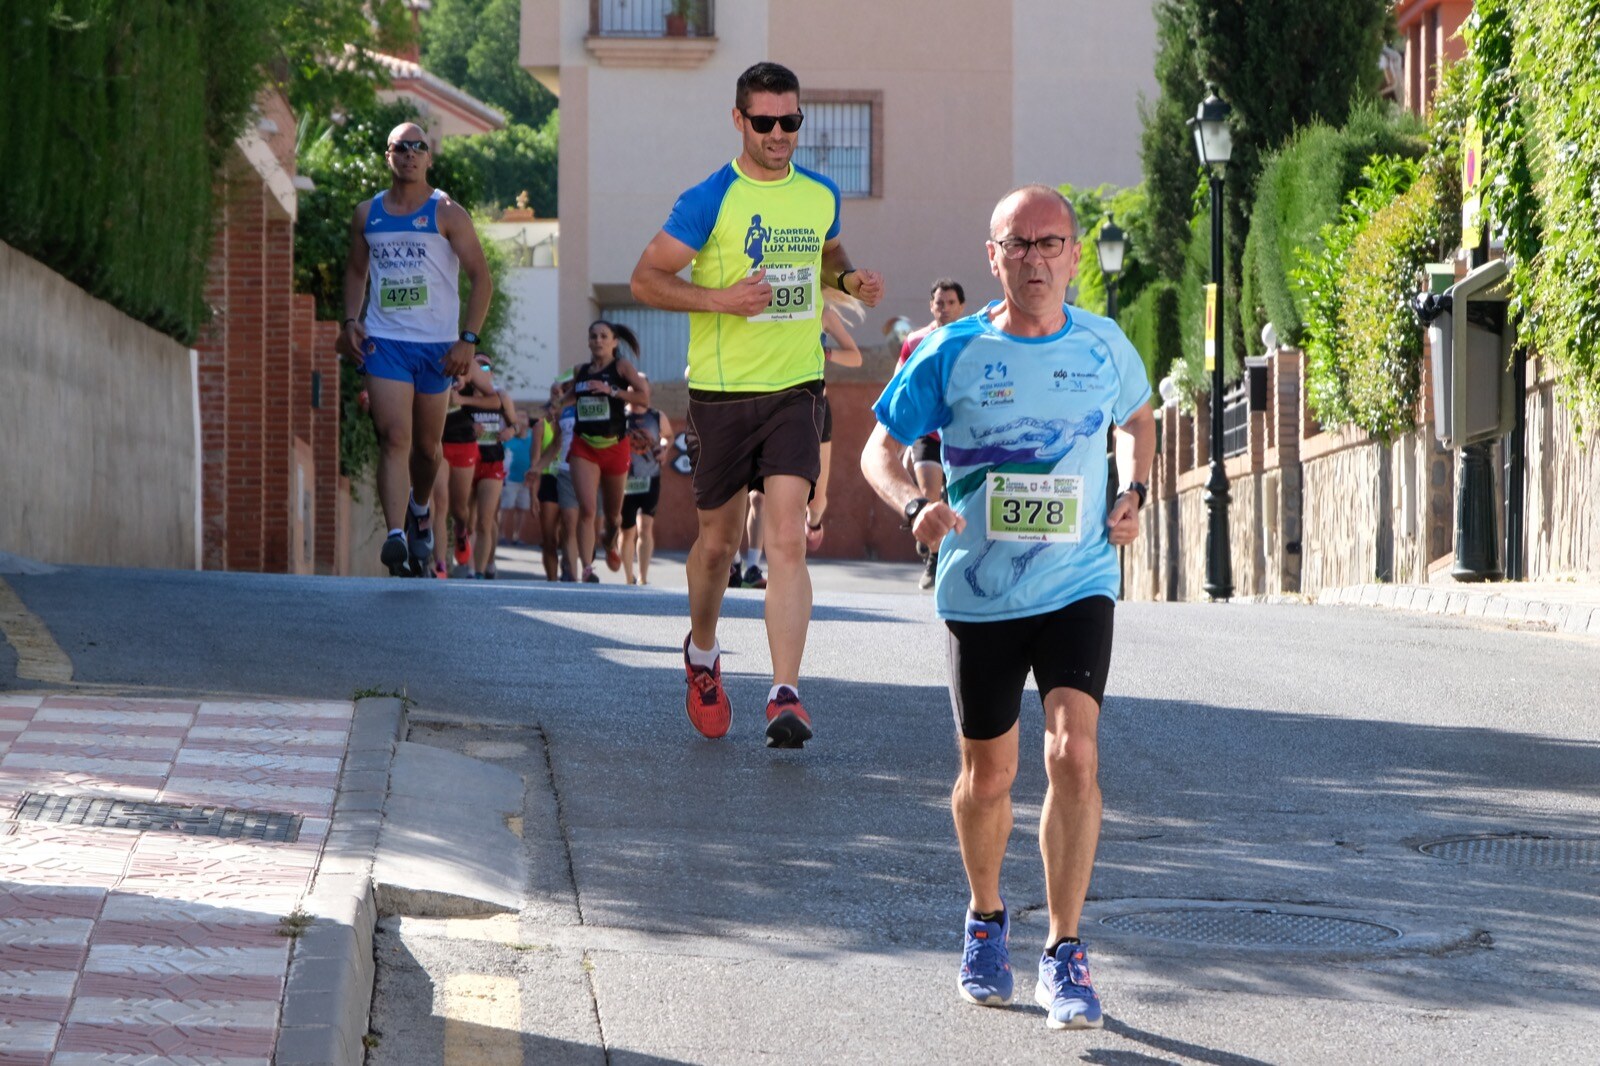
(1429, 259), (1517, 448)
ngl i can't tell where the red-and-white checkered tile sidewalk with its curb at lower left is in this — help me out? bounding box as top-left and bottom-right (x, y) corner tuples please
(0, 693), (398, 1066)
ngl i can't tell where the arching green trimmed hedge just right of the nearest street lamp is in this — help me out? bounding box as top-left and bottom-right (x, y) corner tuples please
(1242, 106), (1427, 346)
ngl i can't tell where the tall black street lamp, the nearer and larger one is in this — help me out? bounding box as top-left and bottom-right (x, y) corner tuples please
(1189, 85), (1234, 600)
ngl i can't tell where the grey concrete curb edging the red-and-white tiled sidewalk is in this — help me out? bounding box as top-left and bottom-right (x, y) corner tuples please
(272, 698), (406, 1066)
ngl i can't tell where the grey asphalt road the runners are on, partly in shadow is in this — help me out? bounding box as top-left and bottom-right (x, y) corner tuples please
(0, 567), (1600, 1066)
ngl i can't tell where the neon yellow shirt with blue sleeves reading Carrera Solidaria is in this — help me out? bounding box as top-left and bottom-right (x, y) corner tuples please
(662, 162), (838, 392)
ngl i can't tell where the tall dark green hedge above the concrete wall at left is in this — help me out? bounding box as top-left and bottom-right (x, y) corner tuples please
(0, 0), (272, 343)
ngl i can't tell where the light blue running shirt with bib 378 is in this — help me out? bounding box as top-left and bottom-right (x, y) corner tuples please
(872, 301), (1150, 621)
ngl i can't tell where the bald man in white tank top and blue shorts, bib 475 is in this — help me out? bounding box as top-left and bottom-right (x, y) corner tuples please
(339, 122), (493, 576)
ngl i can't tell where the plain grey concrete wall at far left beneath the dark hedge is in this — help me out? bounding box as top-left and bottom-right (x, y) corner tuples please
(0, 236), (197, 570)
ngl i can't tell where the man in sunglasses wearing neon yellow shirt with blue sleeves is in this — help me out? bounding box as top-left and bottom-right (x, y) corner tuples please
(632, 62), (883, 747)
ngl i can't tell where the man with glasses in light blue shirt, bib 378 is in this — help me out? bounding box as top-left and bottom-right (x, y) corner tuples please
(861, 186), (1155, 1029)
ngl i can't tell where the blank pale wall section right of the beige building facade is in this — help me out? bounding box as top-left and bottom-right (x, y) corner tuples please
(1011, 0), (1152, 186)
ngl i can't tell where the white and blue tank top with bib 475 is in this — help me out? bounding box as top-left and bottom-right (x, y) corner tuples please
(366, 189), (461, 343)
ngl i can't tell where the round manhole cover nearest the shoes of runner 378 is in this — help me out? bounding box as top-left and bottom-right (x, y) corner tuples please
(1101, 908), (1400, 948)
